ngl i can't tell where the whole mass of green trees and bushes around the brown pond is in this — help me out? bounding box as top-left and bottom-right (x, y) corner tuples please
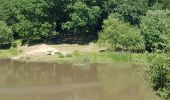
(0, 0), (170, 100)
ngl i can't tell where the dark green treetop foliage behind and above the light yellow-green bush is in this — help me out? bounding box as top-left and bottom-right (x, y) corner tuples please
(102, 0), (149, 24)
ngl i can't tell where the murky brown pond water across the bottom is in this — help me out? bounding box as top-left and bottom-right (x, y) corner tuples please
(0, 60), (158, 100)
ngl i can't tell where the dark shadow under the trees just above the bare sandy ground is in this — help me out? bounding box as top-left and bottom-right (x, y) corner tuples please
(28, 33), (98, 46)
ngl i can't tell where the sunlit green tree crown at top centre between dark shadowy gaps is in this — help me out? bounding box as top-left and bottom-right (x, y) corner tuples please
(62, 0), (100, 34)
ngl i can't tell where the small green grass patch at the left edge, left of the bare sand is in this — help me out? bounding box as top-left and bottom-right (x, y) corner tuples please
(0, 48), (21, 58)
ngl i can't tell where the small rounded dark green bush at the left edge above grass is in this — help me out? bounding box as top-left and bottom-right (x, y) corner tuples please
(0, 21), (13, 47)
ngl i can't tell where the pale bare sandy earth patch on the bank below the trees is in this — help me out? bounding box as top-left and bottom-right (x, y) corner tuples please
(12, 44), (105, 59)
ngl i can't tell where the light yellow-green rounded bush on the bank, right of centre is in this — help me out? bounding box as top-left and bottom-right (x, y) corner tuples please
(98, 14), (144, 52)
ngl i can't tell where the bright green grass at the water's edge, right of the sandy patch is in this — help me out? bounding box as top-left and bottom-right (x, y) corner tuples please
(71, 52), (146, 62)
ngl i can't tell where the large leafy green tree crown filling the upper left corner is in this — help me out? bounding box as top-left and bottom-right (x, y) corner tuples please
(0, 0), (55, 42)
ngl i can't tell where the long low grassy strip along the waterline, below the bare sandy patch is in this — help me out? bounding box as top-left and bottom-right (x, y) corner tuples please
(20, 52), (146, 63)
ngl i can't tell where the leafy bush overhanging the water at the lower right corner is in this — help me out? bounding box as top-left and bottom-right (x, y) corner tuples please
(148, 54), (170, 100)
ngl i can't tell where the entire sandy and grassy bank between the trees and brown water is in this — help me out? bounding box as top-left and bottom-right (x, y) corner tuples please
(0, 44), (146, 63)
